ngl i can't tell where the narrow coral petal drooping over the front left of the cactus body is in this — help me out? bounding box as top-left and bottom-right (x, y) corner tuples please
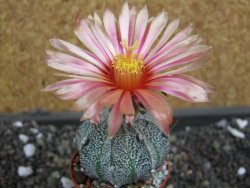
(108, 98), (123, 139)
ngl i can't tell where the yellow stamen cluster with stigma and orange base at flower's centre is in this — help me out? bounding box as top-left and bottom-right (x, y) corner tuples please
(112, 40), (145, 91)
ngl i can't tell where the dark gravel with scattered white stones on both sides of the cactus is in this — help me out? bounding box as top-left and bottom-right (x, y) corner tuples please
(0, 119), (250, 188)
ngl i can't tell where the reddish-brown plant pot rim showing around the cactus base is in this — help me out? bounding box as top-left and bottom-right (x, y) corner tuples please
(69, 151), (170, 188)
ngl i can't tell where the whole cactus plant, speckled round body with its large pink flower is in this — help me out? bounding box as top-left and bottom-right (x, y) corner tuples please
(44, 2), (212, 187)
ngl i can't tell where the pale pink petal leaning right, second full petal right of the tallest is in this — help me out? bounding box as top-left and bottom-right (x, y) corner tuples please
(139, 12), (167, 58)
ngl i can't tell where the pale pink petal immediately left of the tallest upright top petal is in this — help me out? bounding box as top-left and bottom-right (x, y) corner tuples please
(103, 9), (123, 53)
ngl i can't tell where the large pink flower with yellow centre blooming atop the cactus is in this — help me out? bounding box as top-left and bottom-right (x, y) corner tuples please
(44, 3), (211, 137)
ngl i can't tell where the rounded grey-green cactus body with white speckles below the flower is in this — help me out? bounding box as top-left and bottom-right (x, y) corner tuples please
(74, 109), (170, 187)
